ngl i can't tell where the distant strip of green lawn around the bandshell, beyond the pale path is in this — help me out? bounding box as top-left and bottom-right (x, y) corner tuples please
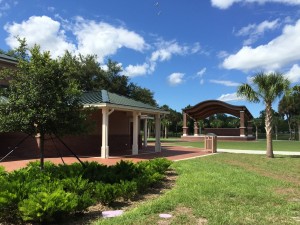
(163, 139), (300, 152)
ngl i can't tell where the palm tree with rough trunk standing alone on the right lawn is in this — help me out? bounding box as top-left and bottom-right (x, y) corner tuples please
(237, 72), (290, 158)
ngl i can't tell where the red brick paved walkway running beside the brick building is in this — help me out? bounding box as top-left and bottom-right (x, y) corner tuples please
(0, 143), (211, 171)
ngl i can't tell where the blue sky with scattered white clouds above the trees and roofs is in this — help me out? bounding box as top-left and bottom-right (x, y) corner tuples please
(0, 0), (300, 117)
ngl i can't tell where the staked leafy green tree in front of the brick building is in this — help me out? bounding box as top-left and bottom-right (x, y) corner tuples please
(0, 42), (85, 169)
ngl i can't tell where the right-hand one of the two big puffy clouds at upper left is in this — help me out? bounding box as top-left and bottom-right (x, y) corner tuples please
(74, 17), (147, 62)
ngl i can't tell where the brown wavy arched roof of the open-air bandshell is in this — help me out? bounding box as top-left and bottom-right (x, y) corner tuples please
(183, 100), (253, 121)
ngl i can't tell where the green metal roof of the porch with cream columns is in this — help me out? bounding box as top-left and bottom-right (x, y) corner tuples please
(81, 90), (169, 114)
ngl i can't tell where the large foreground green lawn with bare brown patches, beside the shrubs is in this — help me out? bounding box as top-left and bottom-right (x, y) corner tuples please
(96, 154), (300, 225)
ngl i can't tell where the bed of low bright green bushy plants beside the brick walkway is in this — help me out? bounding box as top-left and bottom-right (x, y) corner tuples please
(0, 158), (171, 224)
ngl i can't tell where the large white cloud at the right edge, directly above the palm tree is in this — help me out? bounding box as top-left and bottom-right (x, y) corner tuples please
(222, 20), (300, 71)
